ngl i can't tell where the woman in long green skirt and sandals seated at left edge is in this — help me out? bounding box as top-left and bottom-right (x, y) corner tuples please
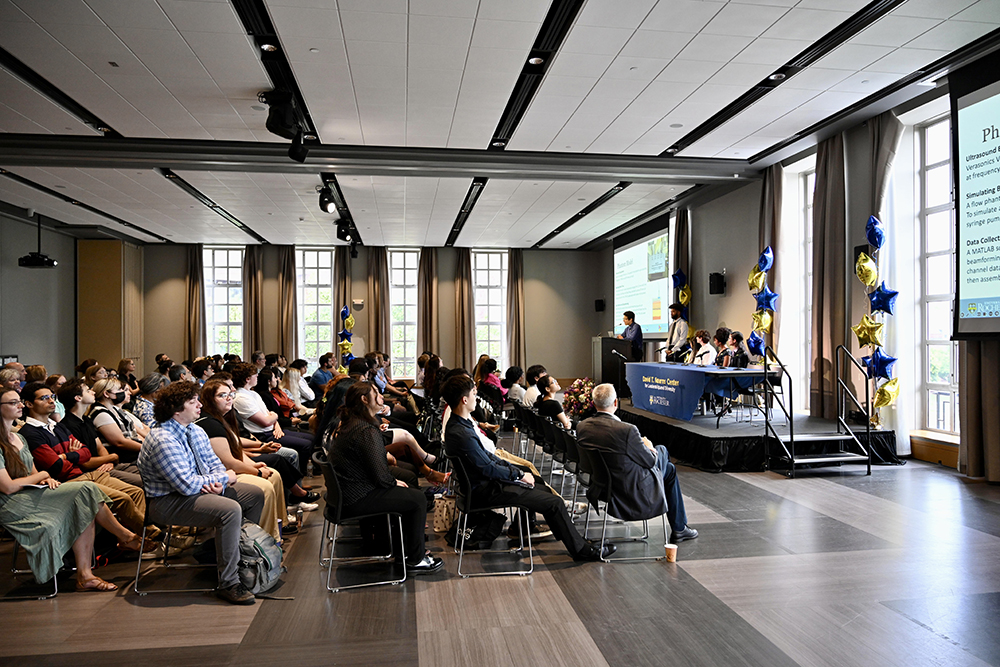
(0, 389), (150, 591)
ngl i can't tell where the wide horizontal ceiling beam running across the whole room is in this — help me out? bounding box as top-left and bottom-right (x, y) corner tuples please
(0, 134), (759, 186)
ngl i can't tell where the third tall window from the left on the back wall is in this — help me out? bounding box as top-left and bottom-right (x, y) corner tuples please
(389, 249), (420, 380)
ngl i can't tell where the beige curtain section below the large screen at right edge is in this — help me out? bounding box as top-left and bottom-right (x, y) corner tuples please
(958, 340), (1000, 482)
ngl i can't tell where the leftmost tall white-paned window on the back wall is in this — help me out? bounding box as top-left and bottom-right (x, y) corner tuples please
(204, 246), (243, 357)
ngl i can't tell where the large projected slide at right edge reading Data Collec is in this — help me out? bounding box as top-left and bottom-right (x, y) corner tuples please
(955, 82), (1000, 335)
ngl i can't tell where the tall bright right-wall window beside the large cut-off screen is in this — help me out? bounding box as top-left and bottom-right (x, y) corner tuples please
(917, 117), (958, 433)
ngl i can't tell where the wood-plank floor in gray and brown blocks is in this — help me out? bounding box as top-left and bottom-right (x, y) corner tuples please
(0, 438), (1000, 667)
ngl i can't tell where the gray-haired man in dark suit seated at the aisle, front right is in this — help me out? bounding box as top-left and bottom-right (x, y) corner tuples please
(576, 384), (698, 544)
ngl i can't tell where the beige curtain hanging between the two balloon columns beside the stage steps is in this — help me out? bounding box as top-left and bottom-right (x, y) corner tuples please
(809, 134), (850, 419)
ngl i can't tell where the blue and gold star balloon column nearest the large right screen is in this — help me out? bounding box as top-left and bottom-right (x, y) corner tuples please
(851, 215), (899, 427)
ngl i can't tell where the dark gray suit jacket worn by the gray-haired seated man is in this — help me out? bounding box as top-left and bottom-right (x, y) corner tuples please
(576, 412), (667, 521)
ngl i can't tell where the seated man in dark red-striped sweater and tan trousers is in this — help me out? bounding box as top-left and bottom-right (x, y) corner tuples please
(19, 382), (148, 536)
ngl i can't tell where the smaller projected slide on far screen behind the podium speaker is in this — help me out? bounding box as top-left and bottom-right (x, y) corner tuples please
(615, 232), (673, 338)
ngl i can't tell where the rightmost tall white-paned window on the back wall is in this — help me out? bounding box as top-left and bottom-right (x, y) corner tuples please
(472, 250), (507, 369)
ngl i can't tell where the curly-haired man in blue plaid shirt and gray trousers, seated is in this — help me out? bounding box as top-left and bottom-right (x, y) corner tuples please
(138, 382), (264, 604)
